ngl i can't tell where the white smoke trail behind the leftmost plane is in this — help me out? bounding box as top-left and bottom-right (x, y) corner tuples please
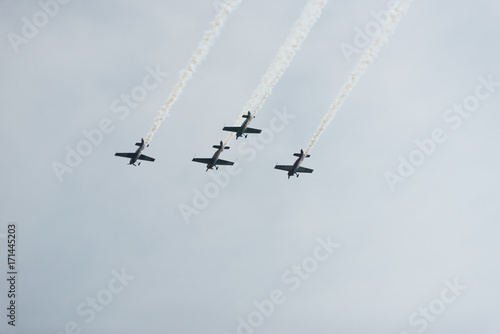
(145, 0), (242, 144)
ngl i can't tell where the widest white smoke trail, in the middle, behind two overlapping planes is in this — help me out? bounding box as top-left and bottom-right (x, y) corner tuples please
(224, 0), (327, 145)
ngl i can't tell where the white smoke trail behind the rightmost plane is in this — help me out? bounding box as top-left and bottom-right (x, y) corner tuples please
(305, 0), (412, 154)
